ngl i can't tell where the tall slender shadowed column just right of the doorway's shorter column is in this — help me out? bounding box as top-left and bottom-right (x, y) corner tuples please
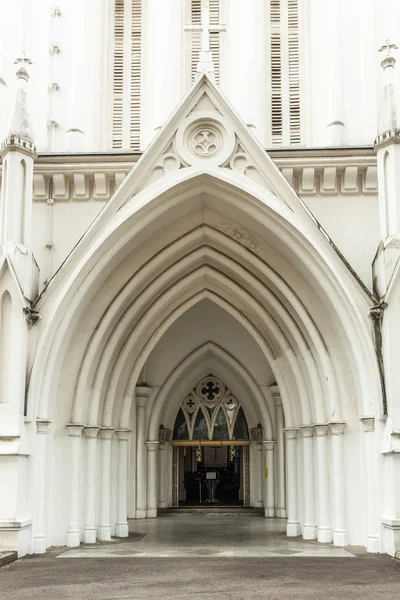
(270, 385), (286, 519)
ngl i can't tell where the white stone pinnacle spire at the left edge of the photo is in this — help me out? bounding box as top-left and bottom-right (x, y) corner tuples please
(2, 53), (36, 154)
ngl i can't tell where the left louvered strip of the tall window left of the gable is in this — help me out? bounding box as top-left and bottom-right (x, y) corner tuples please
(112, 0), (124, 148)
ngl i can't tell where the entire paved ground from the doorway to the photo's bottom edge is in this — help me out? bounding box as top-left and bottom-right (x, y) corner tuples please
(0, 517), (400, 600)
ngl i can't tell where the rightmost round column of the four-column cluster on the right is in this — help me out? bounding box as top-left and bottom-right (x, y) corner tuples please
(329, 423), (349, 546)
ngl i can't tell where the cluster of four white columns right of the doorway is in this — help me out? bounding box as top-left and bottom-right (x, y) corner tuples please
(285, 423), (348, 546)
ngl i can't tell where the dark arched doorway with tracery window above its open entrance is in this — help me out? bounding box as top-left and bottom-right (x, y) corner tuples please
(172, 374), (252, 506)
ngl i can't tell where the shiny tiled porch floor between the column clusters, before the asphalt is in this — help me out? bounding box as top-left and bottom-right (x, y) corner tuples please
(59, 515), (354, 558)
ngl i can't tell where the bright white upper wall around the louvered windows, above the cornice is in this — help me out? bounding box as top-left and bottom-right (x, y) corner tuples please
(0, 0), (400, 152)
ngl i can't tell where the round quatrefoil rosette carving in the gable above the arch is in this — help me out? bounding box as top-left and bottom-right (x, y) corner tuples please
(175, 112), (235, 166)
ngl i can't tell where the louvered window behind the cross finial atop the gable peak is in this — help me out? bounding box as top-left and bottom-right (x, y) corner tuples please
(188, 0), (220, 85)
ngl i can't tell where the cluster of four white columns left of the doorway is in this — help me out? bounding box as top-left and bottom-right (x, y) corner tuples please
(66, 423), (130, 547)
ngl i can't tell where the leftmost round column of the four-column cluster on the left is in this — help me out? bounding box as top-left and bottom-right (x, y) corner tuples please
(66, 423), (83, 548)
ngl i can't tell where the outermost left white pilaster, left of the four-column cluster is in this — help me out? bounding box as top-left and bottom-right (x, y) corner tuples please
(33, 419), (51, 554)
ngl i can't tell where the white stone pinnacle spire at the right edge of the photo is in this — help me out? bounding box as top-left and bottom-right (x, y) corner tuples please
(376, 39), (399, 144)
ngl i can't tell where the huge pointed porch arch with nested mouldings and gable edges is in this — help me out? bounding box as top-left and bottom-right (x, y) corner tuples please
(29, 78), (381, 427)
